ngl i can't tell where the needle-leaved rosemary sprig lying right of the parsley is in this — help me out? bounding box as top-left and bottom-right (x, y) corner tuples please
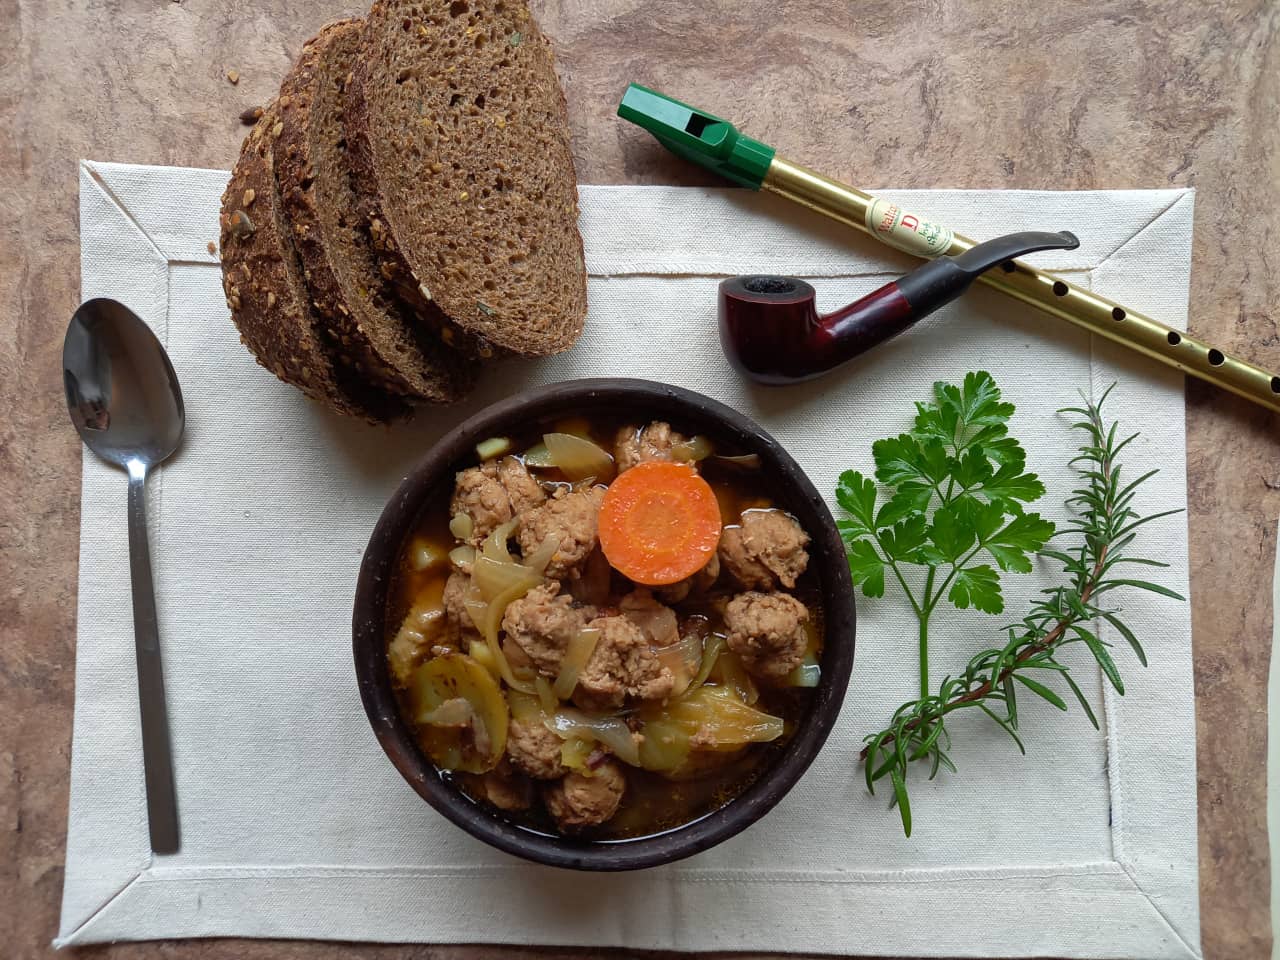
(860, 389), (1183, 836)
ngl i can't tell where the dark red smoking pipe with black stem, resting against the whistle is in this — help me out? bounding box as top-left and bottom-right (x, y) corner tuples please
(719, 230), (1080, 384)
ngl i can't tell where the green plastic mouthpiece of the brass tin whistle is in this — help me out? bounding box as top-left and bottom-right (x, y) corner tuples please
(618, 83), (773, 189)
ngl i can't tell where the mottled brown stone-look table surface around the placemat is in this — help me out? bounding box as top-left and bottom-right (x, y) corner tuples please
(0, 0), (1280, 960)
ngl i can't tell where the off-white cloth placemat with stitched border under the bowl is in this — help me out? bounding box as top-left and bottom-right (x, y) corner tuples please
(56, 163), (1201, 957)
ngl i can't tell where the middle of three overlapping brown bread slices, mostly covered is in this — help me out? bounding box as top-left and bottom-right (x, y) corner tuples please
(274, 19), (476, 403)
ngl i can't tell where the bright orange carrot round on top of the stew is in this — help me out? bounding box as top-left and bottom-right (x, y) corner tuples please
(600, 461), (721, 586)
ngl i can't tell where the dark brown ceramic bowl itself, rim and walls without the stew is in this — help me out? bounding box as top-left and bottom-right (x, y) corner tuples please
(352, 379), (854, 870)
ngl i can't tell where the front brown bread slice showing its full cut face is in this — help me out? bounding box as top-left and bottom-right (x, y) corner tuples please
(347, 0), (586, 356)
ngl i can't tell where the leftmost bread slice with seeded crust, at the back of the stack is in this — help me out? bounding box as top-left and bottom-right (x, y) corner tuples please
(219, 102), (408, 422)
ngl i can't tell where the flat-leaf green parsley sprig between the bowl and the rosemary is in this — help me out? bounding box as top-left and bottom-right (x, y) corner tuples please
(836, 371), (1053, 696)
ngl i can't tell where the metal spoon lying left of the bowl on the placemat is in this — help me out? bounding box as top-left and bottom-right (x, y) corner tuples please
(63, 300), (186, 854)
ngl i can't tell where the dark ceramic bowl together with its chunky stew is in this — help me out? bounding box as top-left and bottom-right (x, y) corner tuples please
(352, 379), (855, 870)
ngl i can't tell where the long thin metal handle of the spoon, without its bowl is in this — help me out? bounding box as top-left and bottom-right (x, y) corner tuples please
(129, 461), (178, 854)
